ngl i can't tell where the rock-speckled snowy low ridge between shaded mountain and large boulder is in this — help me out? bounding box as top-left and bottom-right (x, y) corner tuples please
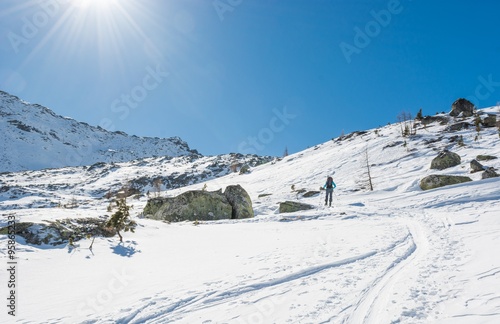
(0, 153), (273, 210)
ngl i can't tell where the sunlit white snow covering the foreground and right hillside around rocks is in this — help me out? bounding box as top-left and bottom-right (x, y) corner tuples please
(0, 108), (500, 324)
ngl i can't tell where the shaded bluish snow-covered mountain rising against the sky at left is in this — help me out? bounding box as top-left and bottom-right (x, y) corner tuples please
(0, 91), (197, 172)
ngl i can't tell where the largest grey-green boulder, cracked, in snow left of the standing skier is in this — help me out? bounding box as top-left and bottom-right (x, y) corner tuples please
(144, 185), (254, 222)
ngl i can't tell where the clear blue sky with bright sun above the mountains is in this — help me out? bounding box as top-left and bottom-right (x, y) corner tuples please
(0, 0), (500, 155)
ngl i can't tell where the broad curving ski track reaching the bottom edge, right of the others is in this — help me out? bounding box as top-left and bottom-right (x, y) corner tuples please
(343, 220), (429, 324)
